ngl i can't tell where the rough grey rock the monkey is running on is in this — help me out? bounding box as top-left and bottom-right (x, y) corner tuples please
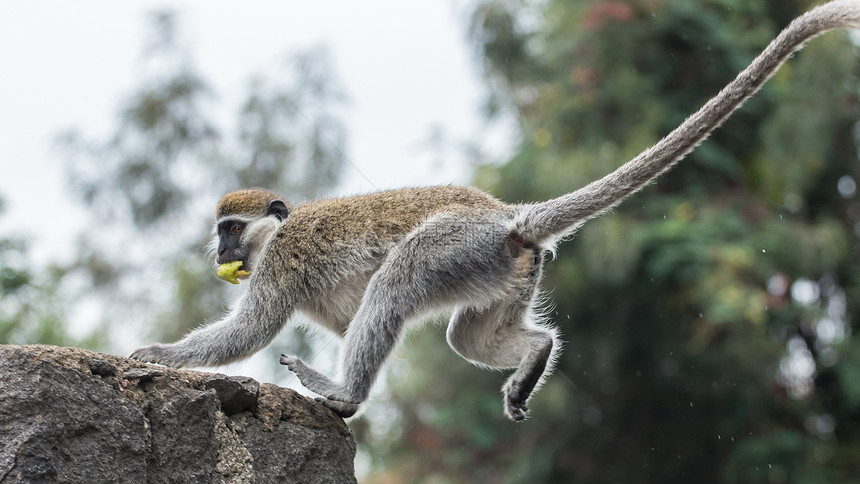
(0, 345), (356, 484)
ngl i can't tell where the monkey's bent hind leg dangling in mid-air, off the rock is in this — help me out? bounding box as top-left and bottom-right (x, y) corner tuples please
(447, 251), (558, 421)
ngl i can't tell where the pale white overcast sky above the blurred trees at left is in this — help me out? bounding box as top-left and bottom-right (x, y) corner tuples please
(0, 0), (507, 260)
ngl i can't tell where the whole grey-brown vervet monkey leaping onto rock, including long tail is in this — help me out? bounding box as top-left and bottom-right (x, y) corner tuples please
(132, 0), (860, 420)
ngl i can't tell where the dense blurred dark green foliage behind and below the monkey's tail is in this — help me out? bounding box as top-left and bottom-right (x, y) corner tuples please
(362, 0), (860, 483)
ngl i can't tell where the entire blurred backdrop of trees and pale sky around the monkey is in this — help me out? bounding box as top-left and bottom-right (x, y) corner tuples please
(0, 0), (860, 483)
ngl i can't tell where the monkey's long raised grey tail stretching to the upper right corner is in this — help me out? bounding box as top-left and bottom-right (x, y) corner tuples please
(514, 0), (860, 242)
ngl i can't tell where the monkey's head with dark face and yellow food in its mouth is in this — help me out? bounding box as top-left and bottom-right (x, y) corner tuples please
(210, 188), (292, 284)
